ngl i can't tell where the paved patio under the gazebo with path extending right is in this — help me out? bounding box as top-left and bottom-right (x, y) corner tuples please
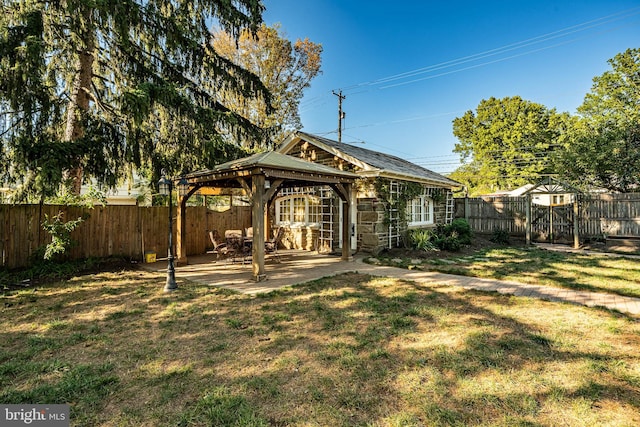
(142, 251), (640, 317)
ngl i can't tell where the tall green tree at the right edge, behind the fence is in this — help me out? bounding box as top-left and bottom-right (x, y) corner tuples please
(558, 49), (640, 192)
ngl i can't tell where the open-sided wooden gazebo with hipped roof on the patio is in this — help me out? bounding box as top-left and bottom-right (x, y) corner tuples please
(176, 151), (358, 281)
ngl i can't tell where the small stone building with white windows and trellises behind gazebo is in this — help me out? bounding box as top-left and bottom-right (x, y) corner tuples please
(276, 132), (461, 253)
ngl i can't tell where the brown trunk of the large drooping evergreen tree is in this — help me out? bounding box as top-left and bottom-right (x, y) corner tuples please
(64, 10), (95, 195)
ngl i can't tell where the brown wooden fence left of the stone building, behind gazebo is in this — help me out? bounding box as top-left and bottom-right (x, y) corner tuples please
(0, 205), (251, 268)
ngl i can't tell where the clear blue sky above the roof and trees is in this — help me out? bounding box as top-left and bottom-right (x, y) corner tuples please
(264, 0), (640, 173)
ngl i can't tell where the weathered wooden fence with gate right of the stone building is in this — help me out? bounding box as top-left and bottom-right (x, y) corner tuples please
(455, 193), (640, 240)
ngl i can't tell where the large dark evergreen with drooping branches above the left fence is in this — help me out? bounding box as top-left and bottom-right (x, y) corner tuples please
(0, 0), (270, 201)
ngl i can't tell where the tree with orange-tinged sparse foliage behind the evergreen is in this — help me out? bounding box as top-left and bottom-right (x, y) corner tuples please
(213, 24), (322, 148)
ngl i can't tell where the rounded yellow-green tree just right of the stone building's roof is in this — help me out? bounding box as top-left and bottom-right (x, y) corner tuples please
(453, 96), (562, 194)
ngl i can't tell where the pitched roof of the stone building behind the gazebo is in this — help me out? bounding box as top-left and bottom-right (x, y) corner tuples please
(278, 131), (462, 187)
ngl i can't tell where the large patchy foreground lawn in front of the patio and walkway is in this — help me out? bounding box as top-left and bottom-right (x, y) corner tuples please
(0, 270), (640, 426)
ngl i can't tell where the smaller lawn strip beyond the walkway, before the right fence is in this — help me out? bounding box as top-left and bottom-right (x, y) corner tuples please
(381, 248), (640, 298)
